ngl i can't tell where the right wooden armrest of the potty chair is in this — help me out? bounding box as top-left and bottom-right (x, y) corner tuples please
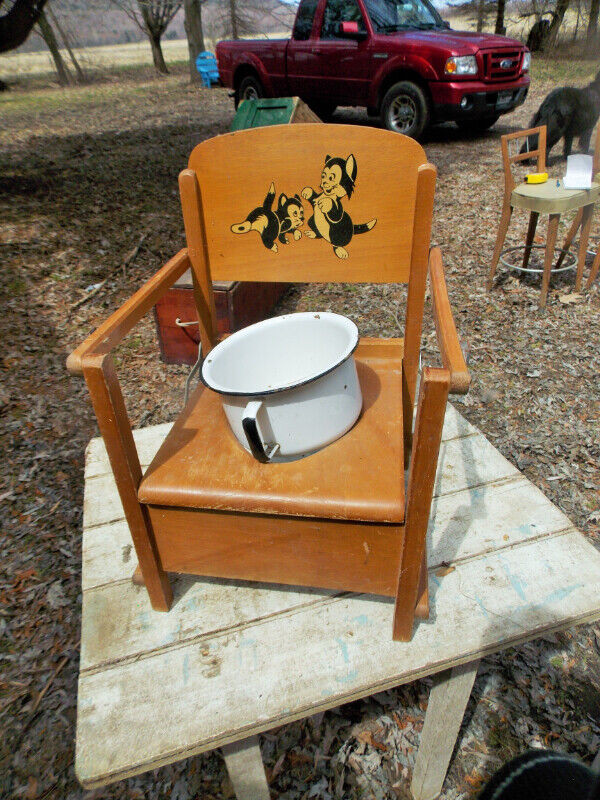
(429, 247), (471, 394)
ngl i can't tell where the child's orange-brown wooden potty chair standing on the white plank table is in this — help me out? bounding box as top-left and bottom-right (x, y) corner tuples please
(68, 124), (469, 640)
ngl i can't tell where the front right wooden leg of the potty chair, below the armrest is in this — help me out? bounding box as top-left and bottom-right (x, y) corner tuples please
(392, 367), (450, 642)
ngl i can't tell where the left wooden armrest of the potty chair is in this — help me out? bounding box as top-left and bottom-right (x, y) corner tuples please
(67, 248), (191, 375)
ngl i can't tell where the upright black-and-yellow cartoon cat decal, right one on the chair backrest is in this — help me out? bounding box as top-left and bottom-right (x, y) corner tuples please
(302, 154), (377, 258)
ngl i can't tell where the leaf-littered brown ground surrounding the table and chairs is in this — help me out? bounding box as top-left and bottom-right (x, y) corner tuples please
(0, 60), (600, 800)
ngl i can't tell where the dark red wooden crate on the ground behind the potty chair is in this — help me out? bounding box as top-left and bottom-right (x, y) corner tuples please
(154, 271), (290, 365)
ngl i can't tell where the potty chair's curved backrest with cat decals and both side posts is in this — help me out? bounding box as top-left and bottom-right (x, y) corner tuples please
(179, 123), (436, 396)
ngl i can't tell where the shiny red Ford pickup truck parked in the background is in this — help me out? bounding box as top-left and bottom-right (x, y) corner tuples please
(217, 0), (530, 138)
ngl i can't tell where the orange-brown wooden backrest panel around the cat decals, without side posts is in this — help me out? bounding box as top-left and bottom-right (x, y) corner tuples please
(184, 124), (428, 283)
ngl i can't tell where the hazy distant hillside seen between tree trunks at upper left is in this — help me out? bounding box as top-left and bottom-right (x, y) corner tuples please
(14, 0), (296, 52)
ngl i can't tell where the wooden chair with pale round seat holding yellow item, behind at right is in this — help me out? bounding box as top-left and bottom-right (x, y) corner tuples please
(487, 125), (600, 308)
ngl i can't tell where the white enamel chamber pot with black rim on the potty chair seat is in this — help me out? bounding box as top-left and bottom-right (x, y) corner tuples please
(201, 311), (362, 463)
